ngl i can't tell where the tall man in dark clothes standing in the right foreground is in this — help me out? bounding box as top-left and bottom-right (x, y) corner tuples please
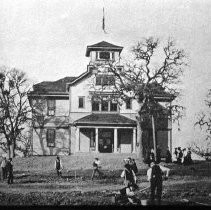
(147, 161), (163, 205)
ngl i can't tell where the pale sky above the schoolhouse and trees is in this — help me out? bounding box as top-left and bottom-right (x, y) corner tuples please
(0, 0), (211, 146)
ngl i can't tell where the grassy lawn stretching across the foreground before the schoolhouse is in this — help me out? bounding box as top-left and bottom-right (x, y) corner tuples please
(0, 156), (211, 206)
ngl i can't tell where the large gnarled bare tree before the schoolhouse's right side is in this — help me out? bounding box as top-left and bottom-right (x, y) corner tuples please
(91, 37), (187, 162)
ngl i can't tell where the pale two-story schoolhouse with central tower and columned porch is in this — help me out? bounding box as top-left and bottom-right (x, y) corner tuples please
(29, 41), (172, 155)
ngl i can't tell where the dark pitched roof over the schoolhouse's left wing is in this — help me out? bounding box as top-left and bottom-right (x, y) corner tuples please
(31, 77), (77, 94)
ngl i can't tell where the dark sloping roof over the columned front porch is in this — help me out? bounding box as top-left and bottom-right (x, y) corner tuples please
(74, 113), (136, 127)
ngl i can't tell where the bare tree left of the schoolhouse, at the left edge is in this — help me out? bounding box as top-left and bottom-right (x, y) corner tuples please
(0, 67), (31, 157)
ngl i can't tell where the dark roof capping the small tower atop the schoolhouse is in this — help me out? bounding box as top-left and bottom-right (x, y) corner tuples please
(86, 41), (123, 57)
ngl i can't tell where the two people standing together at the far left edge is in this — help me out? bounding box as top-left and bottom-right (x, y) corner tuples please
(1, 157), (13, 184)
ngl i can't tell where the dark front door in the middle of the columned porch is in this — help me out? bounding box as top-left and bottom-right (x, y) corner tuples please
(99, 129), (114, 153)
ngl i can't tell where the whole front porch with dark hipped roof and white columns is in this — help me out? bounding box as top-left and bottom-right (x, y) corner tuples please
(74, 114), (137, 153)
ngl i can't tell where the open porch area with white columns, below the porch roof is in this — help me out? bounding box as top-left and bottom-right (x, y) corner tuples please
(75, 126), (137, 153)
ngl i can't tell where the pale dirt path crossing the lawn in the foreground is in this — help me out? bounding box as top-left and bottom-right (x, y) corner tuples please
(0, 179), (211, 194)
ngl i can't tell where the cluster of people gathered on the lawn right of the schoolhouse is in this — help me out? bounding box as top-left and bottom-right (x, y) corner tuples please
(174, 147), (193, 165)
